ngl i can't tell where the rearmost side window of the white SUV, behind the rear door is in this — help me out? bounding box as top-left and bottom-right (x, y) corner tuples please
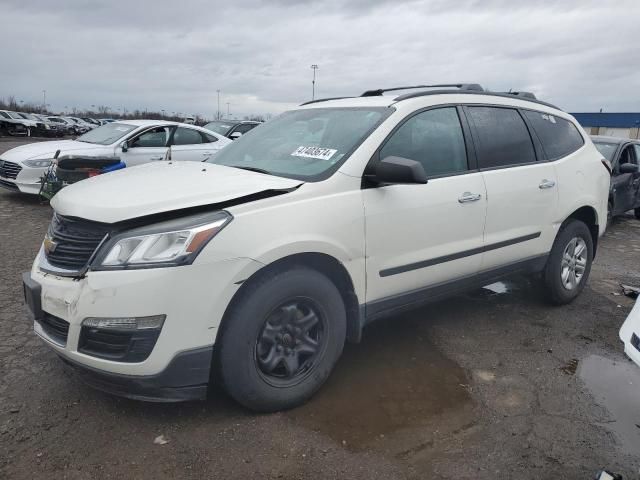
(523, 110), (584, 160)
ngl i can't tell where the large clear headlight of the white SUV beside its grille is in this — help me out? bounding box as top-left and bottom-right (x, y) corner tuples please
(92, 211), (233, 270)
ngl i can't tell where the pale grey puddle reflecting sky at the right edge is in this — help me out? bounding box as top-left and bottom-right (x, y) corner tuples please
(578, 355), (640, 455)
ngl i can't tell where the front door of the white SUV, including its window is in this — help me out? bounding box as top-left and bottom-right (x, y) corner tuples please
(362, 107), (487, 309)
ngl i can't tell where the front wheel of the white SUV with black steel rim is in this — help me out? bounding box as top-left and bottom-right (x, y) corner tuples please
(216, 266), (347, 412)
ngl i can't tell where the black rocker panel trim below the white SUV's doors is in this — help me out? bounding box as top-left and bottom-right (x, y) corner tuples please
(368, 254), (548, 326)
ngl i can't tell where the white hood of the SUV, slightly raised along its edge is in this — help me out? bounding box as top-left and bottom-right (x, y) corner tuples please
(51, 162), (303, 223)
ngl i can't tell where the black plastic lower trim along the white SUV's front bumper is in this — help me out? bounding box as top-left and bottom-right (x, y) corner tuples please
(60, 345), (213, 402)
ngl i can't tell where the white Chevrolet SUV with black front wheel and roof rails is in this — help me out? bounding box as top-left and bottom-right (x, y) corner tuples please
(23, 84), (610, 411)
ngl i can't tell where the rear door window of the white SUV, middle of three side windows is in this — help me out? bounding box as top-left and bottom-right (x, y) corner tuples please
(467, 107), (536, 168)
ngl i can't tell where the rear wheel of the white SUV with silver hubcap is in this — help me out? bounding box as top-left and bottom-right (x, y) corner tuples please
(543, 220), (593, 305)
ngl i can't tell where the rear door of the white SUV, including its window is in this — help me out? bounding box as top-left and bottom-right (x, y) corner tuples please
(465, 106), (558, 270)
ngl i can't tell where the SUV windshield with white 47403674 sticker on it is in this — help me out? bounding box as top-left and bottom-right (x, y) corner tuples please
(208, 108), (392, 181)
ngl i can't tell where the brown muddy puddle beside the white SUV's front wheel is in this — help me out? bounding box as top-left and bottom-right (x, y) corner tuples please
(288, 317), (471, 451)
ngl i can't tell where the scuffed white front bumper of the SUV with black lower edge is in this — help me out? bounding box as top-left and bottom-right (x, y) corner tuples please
(23, 251), (262, 401)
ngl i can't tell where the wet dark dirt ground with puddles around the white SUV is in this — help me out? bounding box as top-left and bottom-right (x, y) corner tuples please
(0, 140), (640, 480)
